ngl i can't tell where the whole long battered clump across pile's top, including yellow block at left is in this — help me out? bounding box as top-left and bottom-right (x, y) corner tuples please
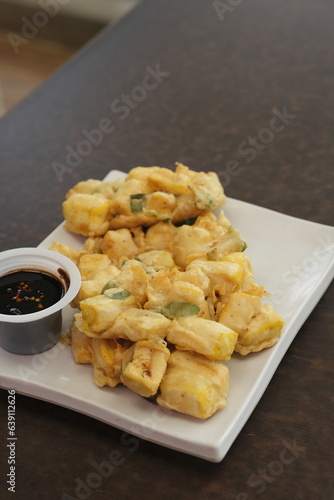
(63, 163), (226, 237)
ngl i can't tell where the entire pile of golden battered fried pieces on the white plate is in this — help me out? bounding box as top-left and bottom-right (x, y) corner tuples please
(59, 163), (284, 419)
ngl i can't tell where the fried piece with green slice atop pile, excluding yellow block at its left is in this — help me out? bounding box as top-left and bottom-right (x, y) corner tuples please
(110, 164), (226, 229)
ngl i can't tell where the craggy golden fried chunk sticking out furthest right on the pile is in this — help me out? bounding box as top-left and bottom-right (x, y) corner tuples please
(218, 292), (284, 356)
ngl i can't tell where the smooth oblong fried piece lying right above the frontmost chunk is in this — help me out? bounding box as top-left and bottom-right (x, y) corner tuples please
(166, 316), (238, 361)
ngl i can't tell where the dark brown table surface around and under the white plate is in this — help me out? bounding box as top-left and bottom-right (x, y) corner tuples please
(0, 0), (334, 500)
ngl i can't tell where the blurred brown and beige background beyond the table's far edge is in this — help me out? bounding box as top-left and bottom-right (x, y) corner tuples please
(0, 0), (142, 117)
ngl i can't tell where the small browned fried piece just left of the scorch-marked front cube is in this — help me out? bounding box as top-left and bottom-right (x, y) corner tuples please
(91, 339), (127, 387)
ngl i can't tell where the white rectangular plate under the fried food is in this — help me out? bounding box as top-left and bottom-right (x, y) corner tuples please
(0, 171), (334, 462)
